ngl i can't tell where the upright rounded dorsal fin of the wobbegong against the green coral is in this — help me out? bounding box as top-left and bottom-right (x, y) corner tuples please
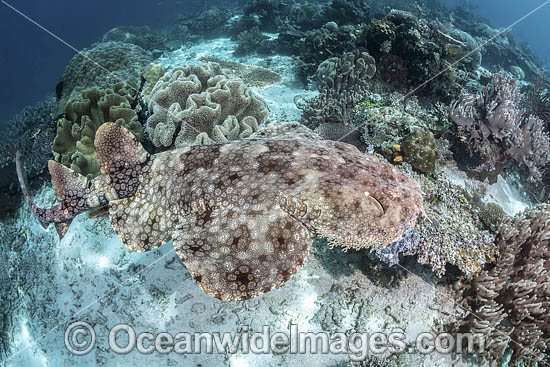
(94, 122), (149, 174)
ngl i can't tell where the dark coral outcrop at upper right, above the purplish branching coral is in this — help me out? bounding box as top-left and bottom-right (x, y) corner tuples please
(366, 10), (474, 100)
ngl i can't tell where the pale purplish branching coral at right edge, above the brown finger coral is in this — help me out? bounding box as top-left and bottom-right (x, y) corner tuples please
(449, 73), (550, 180)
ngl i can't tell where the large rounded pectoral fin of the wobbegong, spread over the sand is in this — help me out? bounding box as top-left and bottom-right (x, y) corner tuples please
(173, 209), (311, 301)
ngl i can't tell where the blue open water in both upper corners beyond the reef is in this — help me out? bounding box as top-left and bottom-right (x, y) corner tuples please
(0, 0), (550, 124)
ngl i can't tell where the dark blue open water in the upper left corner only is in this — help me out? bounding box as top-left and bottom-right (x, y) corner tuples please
(0, 0), (235, 124)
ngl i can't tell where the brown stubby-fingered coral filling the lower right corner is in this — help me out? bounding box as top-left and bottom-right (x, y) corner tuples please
(457, 204), (550, 366)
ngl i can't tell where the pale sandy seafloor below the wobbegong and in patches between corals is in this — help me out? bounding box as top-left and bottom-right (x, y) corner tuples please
(5, 39), (524, 367)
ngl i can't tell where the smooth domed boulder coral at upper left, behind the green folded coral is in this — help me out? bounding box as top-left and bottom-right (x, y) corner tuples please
(55, 41), (153, 115)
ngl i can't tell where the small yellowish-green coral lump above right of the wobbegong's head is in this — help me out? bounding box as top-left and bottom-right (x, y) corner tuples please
(401, 129), (436, 173)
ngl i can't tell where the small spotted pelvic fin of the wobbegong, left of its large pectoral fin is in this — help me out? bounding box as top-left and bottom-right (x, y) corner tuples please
(109, 190), (173, 252)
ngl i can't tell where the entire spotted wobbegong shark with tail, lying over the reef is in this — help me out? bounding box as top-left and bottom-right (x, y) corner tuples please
(17, 123), (422, 300)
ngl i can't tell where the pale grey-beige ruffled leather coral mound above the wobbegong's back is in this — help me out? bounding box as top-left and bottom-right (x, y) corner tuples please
(145, 63), (268, 148)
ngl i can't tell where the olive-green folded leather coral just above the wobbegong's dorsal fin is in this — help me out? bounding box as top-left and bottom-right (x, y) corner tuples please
(52, 83), (143, 177)
